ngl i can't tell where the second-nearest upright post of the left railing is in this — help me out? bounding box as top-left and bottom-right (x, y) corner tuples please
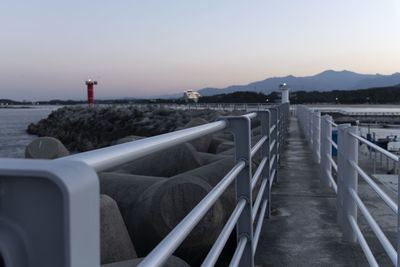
(257, 110), (271, 218)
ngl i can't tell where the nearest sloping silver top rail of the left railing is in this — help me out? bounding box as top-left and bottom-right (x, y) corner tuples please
(60, 120), (227, 171)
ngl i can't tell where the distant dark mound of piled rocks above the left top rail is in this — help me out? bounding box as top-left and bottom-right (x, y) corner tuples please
(27, 105), (244, 152)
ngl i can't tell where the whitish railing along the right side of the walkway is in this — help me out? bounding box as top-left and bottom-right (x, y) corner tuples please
(296, 105), (400, 266)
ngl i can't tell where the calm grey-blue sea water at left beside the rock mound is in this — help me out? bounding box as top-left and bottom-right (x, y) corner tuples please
(0, 107), (58, 158)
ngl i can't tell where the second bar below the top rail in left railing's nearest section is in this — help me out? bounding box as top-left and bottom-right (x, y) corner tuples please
(201, 198), (247, 267)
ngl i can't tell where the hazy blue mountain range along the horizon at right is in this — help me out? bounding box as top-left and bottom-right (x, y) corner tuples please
(155, 70), (400, 98)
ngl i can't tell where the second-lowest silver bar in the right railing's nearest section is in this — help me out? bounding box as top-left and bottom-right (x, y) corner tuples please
(349, 188), (397, 265)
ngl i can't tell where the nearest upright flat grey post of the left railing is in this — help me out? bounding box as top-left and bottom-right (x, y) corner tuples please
(225, 116), (254, 267)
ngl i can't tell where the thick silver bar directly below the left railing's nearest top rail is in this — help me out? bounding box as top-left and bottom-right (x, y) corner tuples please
(139, 161), (246, 267)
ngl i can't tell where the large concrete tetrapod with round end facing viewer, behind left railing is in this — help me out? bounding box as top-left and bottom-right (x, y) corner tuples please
(99, 173), (223, 265)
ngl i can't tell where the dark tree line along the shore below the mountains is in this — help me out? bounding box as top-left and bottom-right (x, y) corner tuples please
(0, 85), (400, 105)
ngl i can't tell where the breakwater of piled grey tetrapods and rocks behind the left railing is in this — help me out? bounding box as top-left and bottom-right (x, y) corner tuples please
(28, 107), (266, 267)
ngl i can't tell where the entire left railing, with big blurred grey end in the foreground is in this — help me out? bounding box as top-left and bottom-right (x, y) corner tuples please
(0, 103), (289, 267)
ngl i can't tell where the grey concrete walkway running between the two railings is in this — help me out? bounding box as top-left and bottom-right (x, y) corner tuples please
(255, 117), (368, 266)
